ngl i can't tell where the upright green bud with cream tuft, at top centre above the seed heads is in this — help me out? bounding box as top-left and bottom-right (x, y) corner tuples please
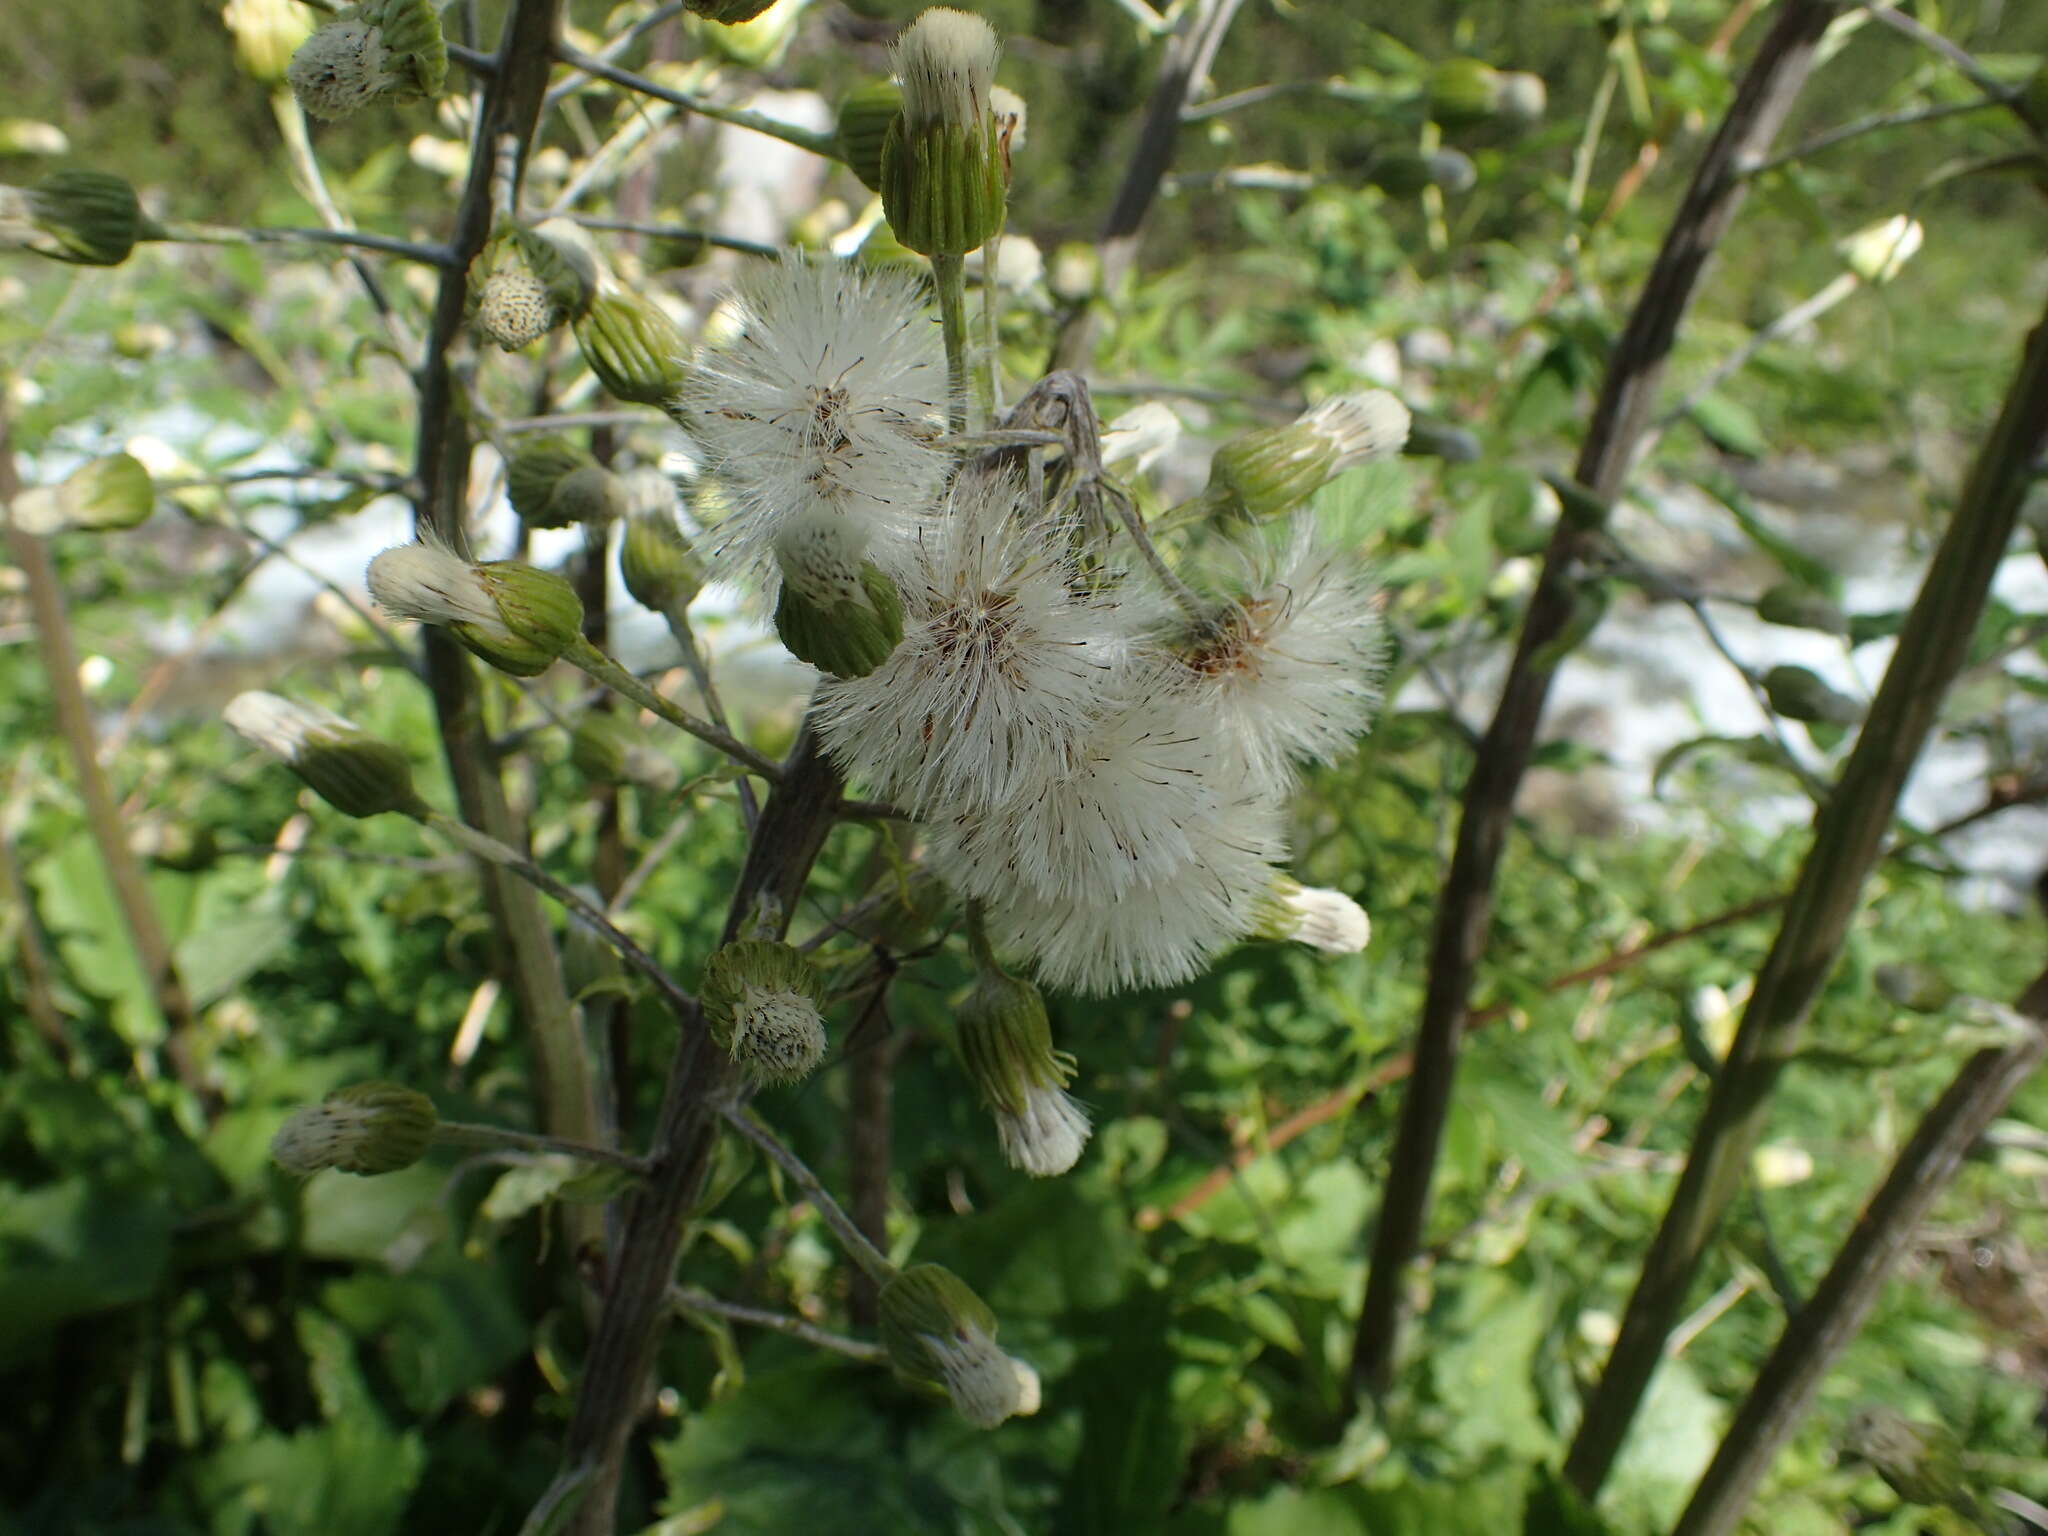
(883, 6), (1010, 256)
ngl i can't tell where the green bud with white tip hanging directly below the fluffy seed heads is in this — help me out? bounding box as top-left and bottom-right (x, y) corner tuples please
(958, 965), (1087, 1178)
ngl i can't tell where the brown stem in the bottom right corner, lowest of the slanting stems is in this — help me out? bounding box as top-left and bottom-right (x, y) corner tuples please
(1671, 973), (2048, 1536)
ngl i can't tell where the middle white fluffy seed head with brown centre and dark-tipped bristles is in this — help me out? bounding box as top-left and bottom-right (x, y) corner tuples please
(819, 477), (1133, 813)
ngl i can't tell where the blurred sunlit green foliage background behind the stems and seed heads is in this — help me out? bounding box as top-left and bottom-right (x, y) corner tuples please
(12, 0), (2048, 1536)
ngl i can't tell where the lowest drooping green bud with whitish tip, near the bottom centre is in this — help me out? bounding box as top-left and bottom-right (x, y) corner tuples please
(877, 1264), (1038, 1430)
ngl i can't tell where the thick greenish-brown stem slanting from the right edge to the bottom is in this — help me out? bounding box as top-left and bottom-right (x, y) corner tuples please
(1565, 282), (2048, 1495)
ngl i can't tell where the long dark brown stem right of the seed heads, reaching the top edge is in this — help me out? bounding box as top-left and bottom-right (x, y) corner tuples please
(1348, 0), (1837, 1399)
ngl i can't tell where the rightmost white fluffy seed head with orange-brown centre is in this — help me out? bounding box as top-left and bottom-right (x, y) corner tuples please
(1171, 528), (1386, 786)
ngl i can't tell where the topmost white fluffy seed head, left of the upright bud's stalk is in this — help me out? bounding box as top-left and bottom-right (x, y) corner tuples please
(682, 256), (948, 598)
